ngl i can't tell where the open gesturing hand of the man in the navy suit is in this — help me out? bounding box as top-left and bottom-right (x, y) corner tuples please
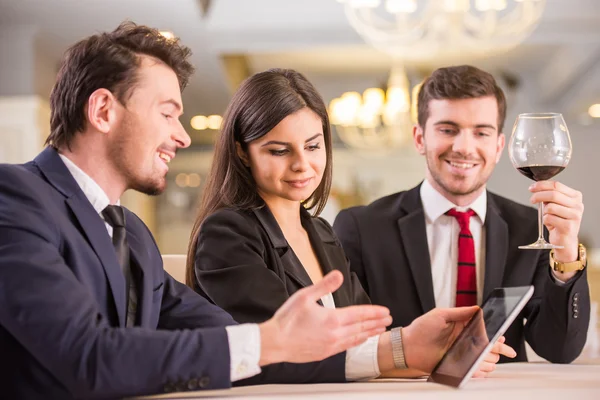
(259, 271), (392, 366)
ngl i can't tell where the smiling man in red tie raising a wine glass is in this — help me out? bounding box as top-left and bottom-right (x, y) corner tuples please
(334, 66), (590, 363)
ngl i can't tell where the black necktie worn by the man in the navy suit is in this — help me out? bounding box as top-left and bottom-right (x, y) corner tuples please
(102, 206), (137, 327)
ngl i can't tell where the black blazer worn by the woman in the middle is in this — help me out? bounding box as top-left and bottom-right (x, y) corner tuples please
(194, 205), (370, 384)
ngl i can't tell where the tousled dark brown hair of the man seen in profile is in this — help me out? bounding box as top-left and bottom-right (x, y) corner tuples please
(46, 21), (194, 149)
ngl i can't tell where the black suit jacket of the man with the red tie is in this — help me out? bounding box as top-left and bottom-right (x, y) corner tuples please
(333, 185), (590, 363)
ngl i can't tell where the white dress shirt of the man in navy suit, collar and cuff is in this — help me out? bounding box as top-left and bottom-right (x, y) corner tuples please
(59, 154), (261, 382)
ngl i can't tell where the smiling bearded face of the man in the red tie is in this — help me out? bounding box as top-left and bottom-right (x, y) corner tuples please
(413, 96), (505, 205)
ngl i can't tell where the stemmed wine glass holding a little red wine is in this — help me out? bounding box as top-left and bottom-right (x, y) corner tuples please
(508, 113), (572, 249)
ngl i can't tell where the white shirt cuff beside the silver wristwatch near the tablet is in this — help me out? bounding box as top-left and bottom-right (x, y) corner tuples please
(346, 335), (381, 381)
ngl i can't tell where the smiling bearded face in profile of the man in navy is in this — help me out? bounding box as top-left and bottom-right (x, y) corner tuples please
(109, 57), (190, 195)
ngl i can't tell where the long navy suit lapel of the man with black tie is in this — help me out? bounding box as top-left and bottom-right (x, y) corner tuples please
(34, 147), (126, 326)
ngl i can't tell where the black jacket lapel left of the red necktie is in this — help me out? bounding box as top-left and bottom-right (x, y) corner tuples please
(393, 185), (435, 313)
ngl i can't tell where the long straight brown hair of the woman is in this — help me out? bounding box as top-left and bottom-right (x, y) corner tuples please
(186, 69), (331, 288)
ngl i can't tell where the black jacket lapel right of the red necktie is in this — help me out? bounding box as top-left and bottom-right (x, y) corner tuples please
(483, 192), (508, 301)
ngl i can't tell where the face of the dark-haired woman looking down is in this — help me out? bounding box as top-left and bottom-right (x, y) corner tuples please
(238, 108), (327, 203)
